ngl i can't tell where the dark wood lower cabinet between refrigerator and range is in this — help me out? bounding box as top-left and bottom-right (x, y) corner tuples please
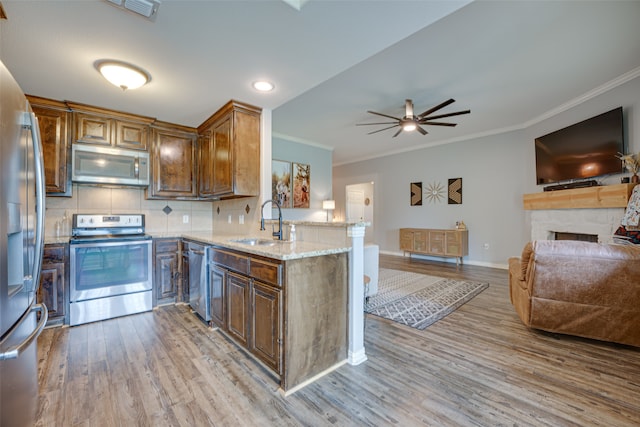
(36, 244), (69, 325)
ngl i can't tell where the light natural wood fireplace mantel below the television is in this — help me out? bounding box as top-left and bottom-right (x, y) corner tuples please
(522, 184), (637, 210)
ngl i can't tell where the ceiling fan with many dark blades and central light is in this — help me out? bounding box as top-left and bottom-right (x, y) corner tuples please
(356, 99), (471, 138)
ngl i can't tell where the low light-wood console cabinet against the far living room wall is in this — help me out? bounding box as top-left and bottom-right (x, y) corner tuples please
(400, 228), (469, 265)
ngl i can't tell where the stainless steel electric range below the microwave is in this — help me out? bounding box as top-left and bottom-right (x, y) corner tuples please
(69, 214), (153, 326)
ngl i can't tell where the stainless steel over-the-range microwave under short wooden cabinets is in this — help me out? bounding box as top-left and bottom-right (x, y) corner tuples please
(71, 144), (149, 187)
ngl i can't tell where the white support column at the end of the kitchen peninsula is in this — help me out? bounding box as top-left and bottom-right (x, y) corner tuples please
(347, 225), (367, 365)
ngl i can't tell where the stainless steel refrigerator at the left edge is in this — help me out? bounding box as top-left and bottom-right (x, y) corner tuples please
(0, 62), (48, 427)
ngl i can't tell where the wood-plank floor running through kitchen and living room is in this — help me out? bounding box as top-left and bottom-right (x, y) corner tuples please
(38, 255), (640, 426)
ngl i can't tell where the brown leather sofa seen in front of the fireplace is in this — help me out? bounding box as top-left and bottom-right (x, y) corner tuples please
(509, 240), (640, 347)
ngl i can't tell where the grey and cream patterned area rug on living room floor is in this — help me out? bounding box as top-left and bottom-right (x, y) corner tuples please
(365, 268), (489, 329)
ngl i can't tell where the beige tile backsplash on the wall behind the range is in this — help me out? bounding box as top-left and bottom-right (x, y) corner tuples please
(45, 184), (214, 237)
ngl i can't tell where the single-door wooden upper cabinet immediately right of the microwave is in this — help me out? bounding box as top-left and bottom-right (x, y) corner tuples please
(147, 124), (198, 199)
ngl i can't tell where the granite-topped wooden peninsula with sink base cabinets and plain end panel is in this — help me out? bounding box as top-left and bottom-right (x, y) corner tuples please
(182, 232), (350, 395)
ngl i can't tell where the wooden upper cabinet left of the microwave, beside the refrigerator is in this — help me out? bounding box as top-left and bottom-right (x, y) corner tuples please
(27, 96), (71, 197)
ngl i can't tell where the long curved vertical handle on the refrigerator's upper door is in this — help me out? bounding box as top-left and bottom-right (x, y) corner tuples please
(28, 112), (45, 292)
